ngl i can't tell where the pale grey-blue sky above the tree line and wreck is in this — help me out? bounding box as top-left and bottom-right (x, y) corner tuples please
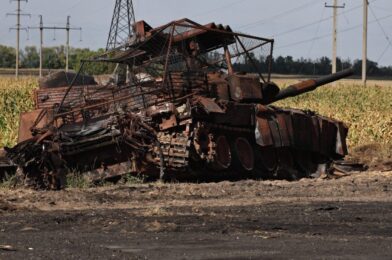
(0, 0), (392, 66)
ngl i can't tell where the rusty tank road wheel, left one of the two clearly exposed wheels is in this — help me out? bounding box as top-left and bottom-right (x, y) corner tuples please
(211, 135), (232, 171)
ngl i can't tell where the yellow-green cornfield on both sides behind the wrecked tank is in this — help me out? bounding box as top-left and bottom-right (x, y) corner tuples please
(0, 78), (392, 147)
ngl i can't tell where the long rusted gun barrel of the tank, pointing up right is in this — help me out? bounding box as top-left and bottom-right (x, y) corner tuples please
(268, 68), (354, 104)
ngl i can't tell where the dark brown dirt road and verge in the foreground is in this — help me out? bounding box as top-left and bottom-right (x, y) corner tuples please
(0, 172), (392, 259)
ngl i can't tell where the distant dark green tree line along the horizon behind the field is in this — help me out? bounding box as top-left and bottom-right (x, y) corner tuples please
(0, 45), (392, 77)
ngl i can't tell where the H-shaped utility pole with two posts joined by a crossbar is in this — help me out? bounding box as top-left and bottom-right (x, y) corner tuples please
(29, 15), (82, 77)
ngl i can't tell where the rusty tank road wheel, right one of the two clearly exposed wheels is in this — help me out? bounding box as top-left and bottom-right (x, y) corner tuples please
(233, 137), (255, 172)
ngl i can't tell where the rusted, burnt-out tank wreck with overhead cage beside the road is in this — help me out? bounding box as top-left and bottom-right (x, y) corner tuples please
(6, 19), (353, 188)
